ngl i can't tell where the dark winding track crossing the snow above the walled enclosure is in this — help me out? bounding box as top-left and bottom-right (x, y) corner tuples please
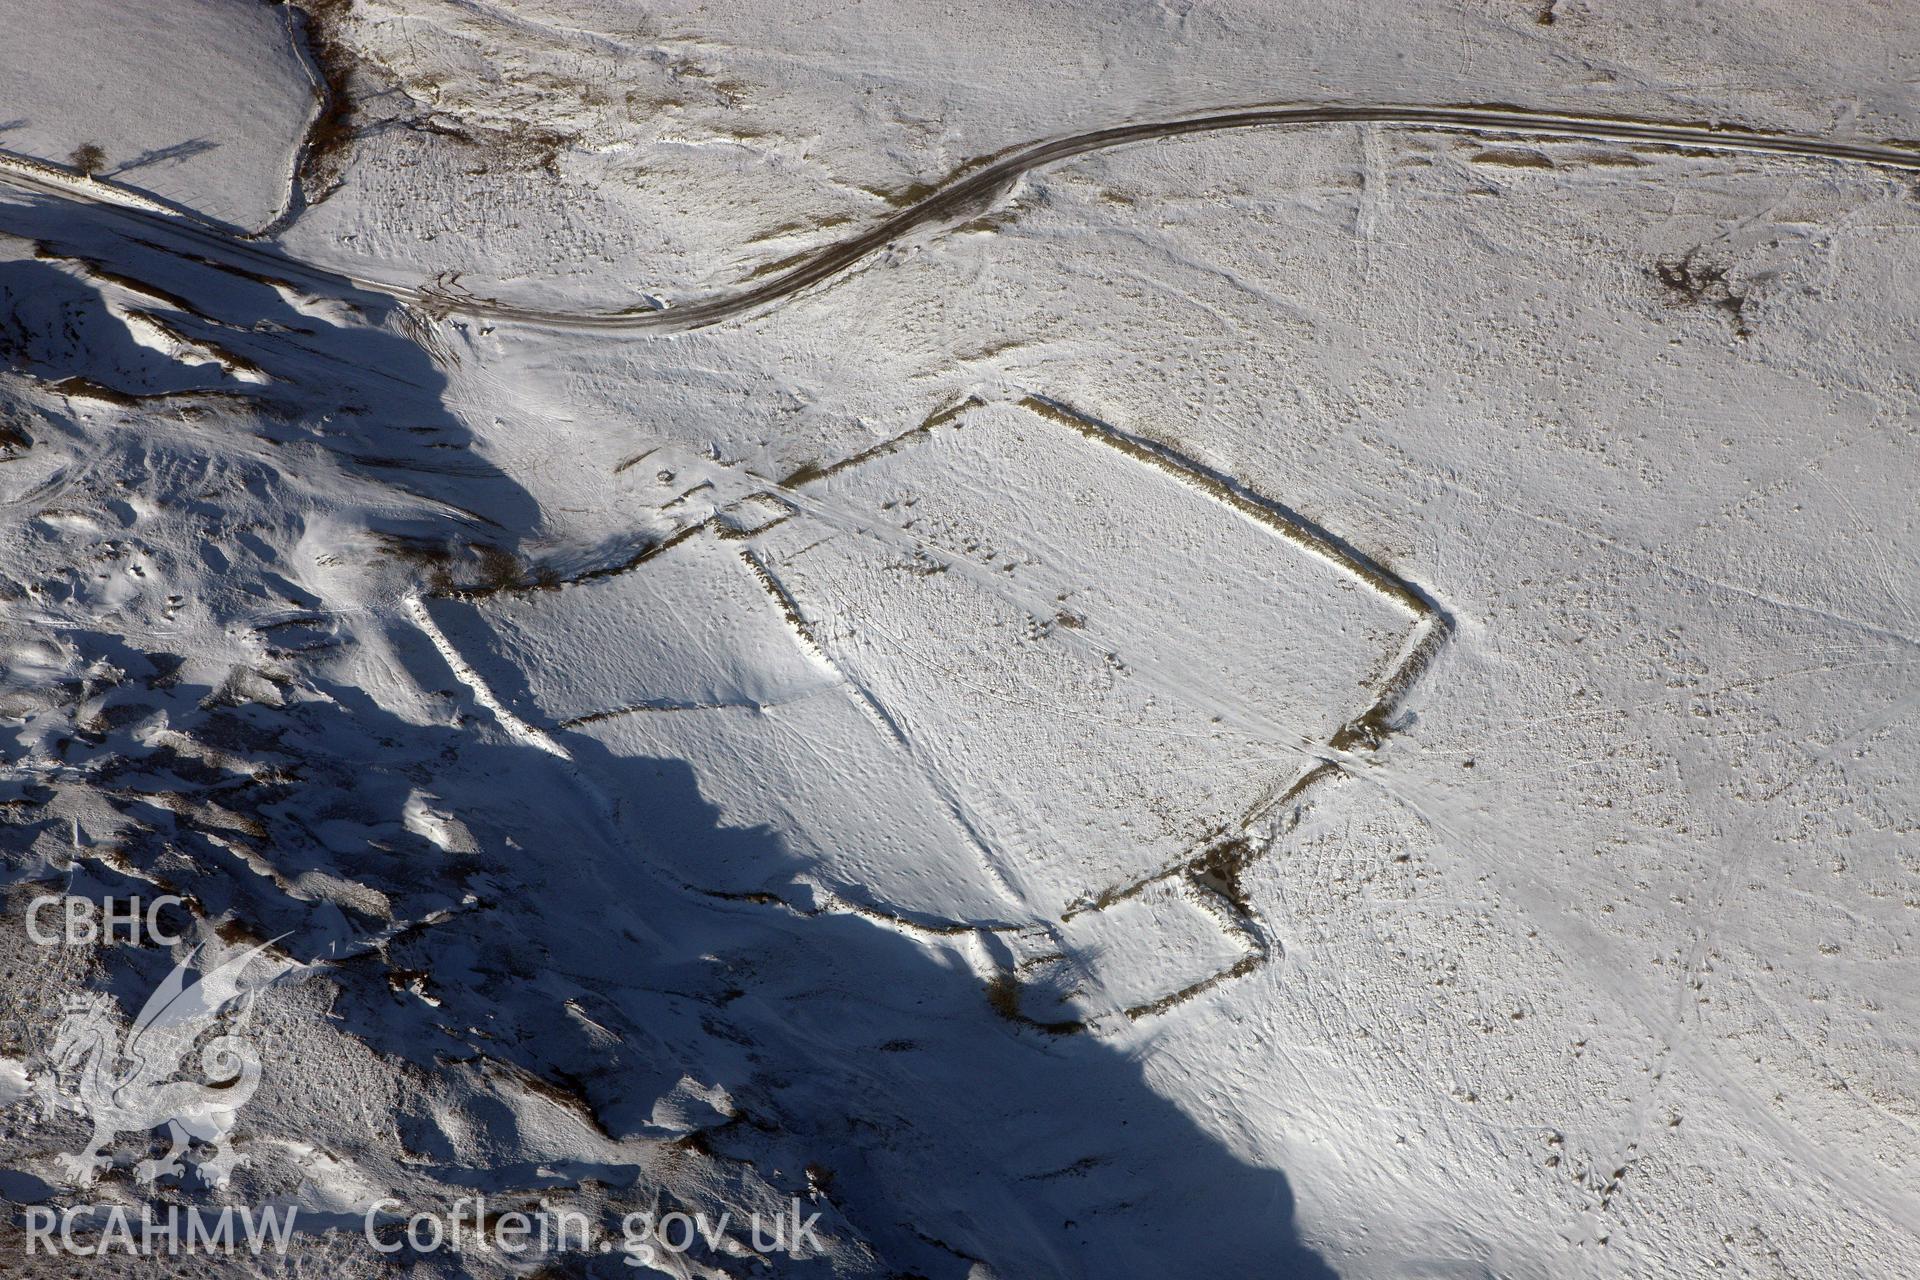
(0, 106), (1920, 332)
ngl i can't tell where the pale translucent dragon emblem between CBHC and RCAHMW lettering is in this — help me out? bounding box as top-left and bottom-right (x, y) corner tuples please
(38, 942), (271, 1186)
